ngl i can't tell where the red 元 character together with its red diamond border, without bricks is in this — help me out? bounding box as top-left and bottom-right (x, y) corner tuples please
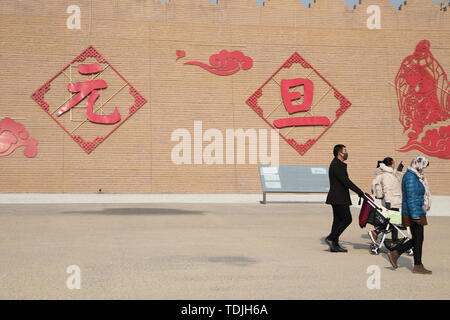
(31, 46), (147, 154)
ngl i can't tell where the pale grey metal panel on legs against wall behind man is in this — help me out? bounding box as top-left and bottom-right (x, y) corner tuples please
(259, 165), (330, 204)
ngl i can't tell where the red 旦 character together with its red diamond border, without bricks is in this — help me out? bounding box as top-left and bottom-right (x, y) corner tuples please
(246, 52), (352, 155)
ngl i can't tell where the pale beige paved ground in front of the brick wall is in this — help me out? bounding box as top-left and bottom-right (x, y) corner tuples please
(0, 203), (450, 299)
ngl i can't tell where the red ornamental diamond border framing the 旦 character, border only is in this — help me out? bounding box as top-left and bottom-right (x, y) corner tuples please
(246, 52), (352, 156)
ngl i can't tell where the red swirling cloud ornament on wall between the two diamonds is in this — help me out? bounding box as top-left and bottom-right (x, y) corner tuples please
(183, 50), (253, 76)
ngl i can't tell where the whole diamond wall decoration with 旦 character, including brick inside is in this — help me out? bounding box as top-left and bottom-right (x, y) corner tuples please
(246, 52), (352, 156)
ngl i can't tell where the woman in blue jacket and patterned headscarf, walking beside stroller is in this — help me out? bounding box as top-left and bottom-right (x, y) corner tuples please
(388, 156), (431, 274)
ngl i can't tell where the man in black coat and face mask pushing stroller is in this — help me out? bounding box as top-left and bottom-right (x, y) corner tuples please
(325, 144), (364, 252)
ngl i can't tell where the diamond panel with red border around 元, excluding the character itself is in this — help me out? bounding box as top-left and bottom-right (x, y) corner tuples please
(31, 46), (147, 154)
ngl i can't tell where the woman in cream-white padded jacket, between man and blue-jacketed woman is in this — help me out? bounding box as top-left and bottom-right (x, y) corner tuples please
(369, 157), (403, 242)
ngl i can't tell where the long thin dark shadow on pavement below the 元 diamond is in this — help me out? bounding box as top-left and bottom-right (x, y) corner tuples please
(62, 208), (204, 216)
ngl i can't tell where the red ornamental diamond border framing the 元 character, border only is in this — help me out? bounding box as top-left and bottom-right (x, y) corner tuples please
(31, 45), (147, 154)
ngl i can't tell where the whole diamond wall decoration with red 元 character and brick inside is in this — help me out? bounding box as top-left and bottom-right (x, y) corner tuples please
(31, 46), (147, 154)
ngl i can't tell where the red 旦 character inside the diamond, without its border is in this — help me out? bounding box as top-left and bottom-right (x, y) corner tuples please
(273, 79), (330, 129)
